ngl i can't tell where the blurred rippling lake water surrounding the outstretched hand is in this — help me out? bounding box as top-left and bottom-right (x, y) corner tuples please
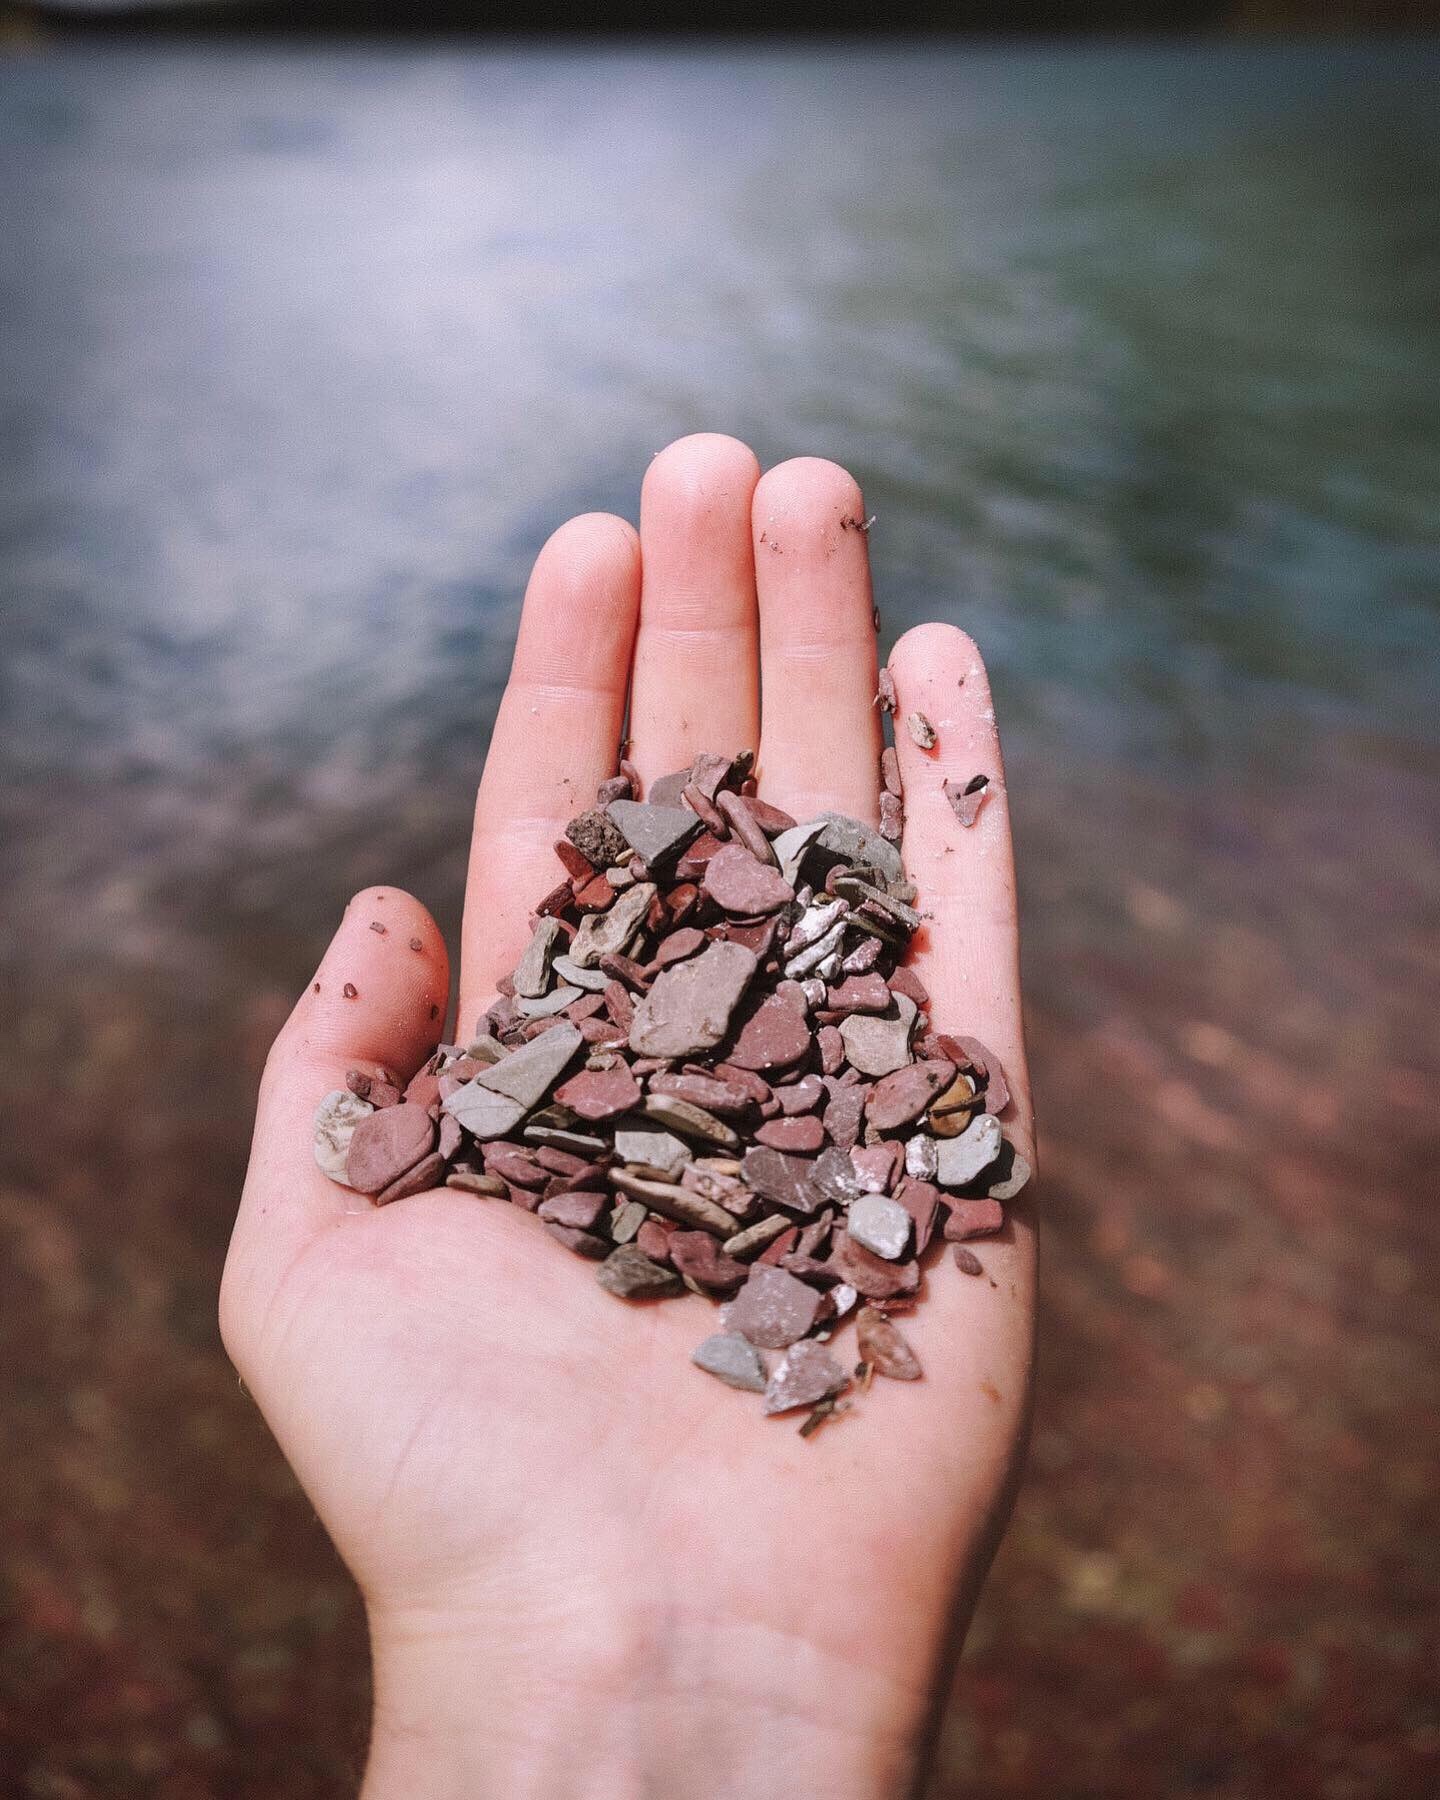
(0, 43), (1440, 1800)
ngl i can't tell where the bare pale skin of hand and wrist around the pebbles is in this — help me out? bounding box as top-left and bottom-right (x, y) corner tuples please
(220, 436), (1035, 1800)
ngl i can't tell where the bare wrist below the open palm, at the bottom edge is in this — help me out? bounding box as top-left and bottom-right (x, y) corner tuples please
(364, 1595), (931, 1800)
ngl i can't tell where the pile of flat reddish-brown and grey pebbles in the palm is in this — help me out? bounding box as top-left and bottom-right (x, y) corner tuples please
(315, 730), (1030, 1435)
